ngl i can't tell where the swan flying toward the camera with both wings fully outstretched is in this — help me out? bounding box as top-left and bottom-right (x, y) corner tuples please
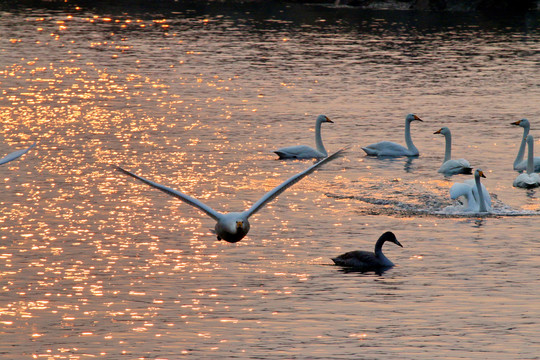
(116, 150), (343, 243)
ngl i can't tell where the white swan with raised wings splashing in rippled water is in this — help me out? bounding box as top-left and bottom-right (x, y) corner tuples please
(450, 169), (491, 213)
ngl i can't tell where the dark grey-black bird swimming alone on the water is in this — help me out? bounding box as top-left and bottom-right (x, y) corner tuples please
(332, 231), (403, 271)
